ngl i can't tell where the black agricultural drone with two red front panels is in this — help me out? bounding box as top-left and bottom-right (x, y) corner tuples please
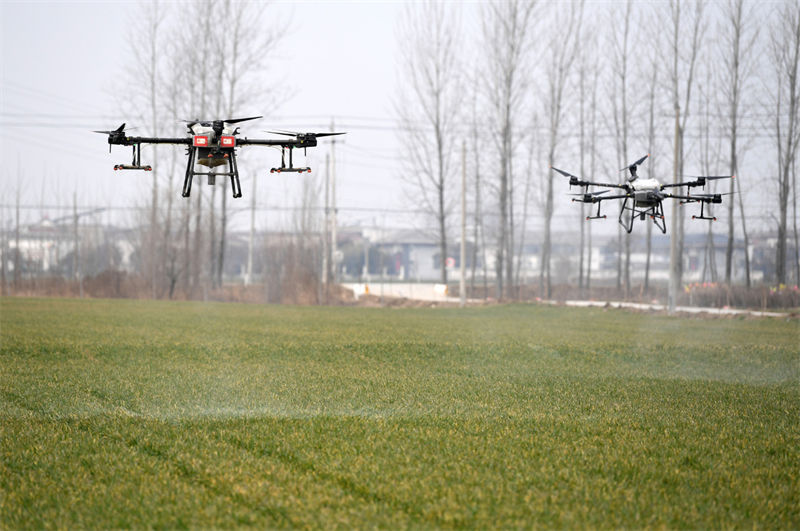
(94, 116), (345, 199)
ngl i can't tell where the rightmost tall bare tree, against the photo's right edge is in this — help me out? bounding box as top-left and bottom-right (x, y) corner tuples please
(770, 2), (800, 284)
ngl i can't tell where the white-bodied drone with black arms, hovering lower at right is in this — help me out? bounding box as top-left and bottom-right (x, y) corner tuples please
(550, 154), (735, 234)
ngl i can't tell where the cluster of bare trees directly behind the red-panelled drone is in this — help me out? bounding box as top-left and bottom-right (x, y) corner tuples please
(118, 0), (280, 296)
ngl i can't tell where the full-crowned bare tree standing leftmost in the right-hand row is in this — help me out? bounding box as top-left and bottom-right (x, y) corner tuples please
(397, 1), (462, 283)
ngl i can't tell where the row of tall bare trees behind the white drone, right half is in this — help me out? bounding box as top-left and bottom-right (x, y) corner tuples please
(397, 0), (800, 298)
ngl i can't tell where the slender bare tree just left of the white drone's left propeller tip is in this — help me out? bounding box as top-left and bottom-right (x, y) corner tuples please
(539, 1), (584, 298)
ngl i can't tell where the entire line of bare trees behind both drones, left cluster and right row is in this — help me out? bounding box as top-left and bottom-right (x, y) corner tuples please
(78, 0), (800, 299)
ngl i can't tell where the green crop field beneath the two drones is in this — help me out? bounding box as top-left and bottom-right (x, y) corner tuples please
(0, 299), (800, 529)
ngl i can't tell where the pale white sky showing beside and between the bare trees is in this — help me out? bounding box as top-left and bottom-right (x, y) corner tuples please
(0, 0), (788, 237)
